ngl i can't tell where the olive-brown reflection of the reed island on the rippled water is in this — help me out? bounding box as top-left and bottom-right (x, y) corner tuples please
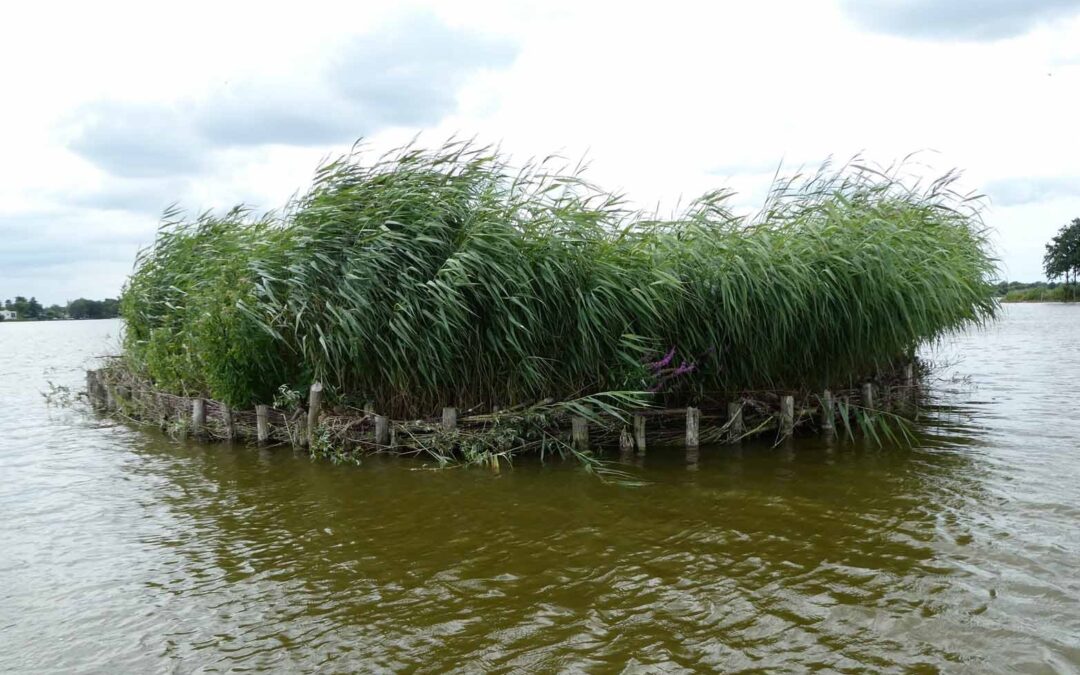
(109, 410), (984, 670)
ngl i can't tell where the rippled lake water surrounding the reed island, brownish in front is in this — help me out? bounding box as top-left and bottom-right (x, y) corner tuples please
(0, 305), (1080, 673)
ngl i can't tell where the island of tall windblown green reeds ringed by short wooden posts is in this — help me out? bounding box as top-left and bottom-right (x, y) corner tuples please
(87, 143), (997, 465)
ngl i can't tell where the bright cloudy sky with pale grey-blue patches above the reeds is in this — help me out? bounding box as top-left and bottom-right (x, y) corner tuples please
(0, 0), (1080, 305)
